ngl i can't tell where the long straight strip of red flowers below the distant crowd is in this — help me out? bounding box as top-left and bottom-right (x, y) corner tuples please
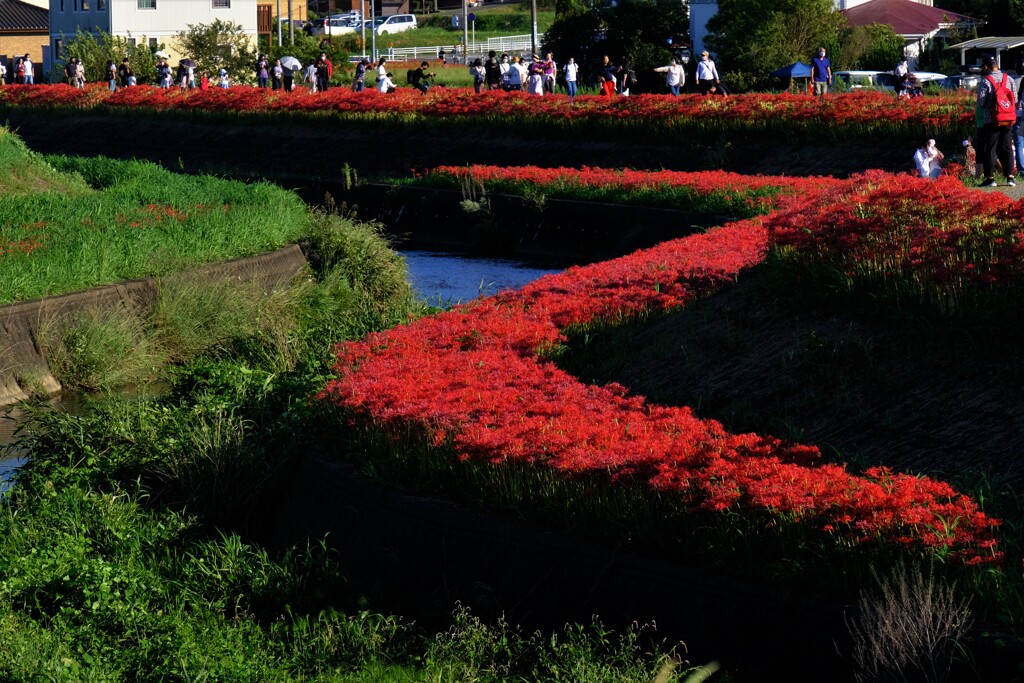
(0, 84), (974, 137)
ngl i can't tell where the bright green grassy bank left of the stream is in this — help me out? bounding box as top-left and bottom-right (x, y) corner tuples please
(0, 133), (309, 304)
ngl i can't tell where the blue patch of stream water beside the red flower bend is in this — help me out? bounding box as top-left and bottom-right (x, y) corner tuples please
(401, 251), (562, 308)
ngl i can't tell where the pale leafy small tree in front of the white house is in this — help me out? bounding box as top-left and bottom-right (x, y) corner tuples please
(174, 19), (258, 83)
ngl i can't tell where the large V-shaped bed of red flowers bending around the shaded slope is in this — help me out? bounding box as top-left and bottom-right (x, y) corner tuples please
(321, 166), (1007, 564)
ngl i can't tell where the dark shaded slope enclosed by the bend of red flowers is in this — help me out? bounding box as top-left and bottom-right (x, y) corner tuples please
(568, 273), (1024, 489)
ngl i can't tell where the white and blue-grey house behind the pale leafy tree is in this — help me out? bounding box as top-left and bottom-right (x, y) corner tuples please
(49, 0), (256, 64)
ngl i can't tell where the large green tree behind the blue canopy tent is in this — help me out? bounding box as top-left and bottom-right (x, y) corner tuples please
(707, 0), (846, 87)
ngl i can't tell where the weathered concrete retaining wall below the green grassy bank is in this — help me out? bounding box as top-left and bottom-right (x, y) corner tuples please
(0, 245), (306, 405)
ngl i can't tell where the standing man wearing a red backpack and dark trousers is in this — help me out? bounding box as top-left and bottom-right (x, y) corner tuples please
(975, 55), (1017, 187)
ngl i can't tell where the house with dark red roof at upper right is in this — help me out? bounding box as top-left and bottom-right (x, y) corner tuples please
(843, 0), (979, 71)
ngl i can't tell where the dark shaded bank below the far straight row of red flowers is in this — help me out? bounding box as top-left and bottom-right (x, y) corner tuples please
(3, 110), (914, 184)
